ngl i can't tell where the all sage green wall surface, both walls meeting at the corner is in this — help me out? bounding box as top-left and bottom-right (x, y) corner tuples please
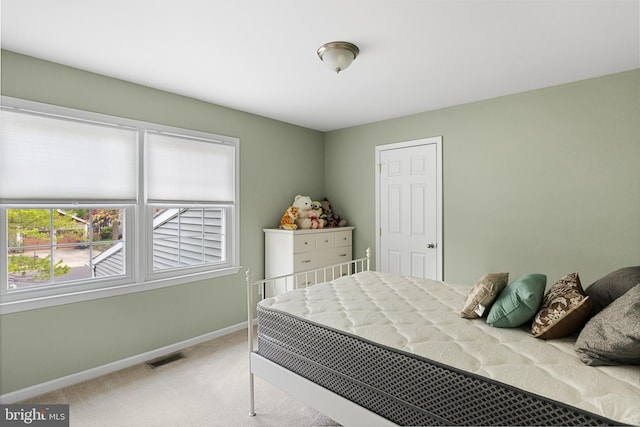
(0, 51), (640, 394)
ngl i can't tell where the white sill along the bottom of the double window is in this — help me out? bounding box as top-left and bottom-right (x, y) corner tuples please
(0, 266), (242, 314)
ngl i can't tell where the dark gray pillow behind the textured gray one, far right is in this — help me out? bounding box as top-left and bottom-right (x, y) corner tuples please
(585, 265), (640, 314)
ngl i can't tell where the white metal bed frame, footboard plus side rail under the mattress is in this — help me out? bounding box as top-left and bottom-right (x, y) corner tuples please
(246, 248), (395, 426)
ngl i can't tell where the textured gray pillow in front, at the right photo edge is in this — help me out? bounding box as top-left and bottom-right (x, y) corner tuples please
(575, 284), (640, 365)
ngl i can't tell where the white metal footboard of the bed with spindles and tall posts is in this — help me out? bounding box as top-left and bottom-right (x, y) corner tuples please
(246, 248), (371, 416)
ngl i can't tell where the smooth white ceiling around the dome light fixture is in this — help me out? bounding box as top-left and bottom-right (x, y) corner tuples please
(1, 0), (640, 131)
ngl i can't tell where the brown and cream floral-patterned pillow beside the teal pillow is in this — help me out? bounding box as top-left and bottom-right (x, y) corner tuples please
(531, 273), (591, 339)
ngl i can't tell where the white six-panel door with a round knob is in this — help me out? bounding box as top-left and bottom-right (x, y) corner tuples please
(376, 137), (442, 280)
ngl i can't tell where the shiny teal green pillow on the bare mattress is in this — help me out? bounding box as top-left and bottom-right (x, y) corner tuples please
(487, 274), (547, 328)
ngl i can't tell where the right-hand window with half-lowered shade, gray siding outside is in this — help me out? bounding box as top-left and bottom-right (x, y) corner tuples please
(145, 131), (236, 275)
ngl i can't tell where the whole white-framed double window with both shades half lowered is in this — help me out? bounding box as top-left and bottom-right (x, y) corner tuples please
(0, 97), (239, 312)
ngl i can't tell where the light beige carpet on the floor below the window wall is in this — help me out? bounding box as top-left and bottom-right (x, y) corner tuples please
(25, 331), (338, 427)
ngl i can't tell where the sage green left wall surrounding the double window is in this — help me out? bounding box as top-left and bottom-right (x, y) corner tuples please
(0, 51), (324, 394)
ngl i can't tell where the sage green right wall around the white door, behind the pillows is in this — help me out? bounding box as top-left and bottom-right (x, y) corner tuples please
(325, 70), (640, 286)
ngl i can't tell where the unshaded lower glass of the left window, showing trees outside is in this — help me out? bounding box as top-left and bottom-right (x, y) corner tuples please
(7, 208), (126, 291)
